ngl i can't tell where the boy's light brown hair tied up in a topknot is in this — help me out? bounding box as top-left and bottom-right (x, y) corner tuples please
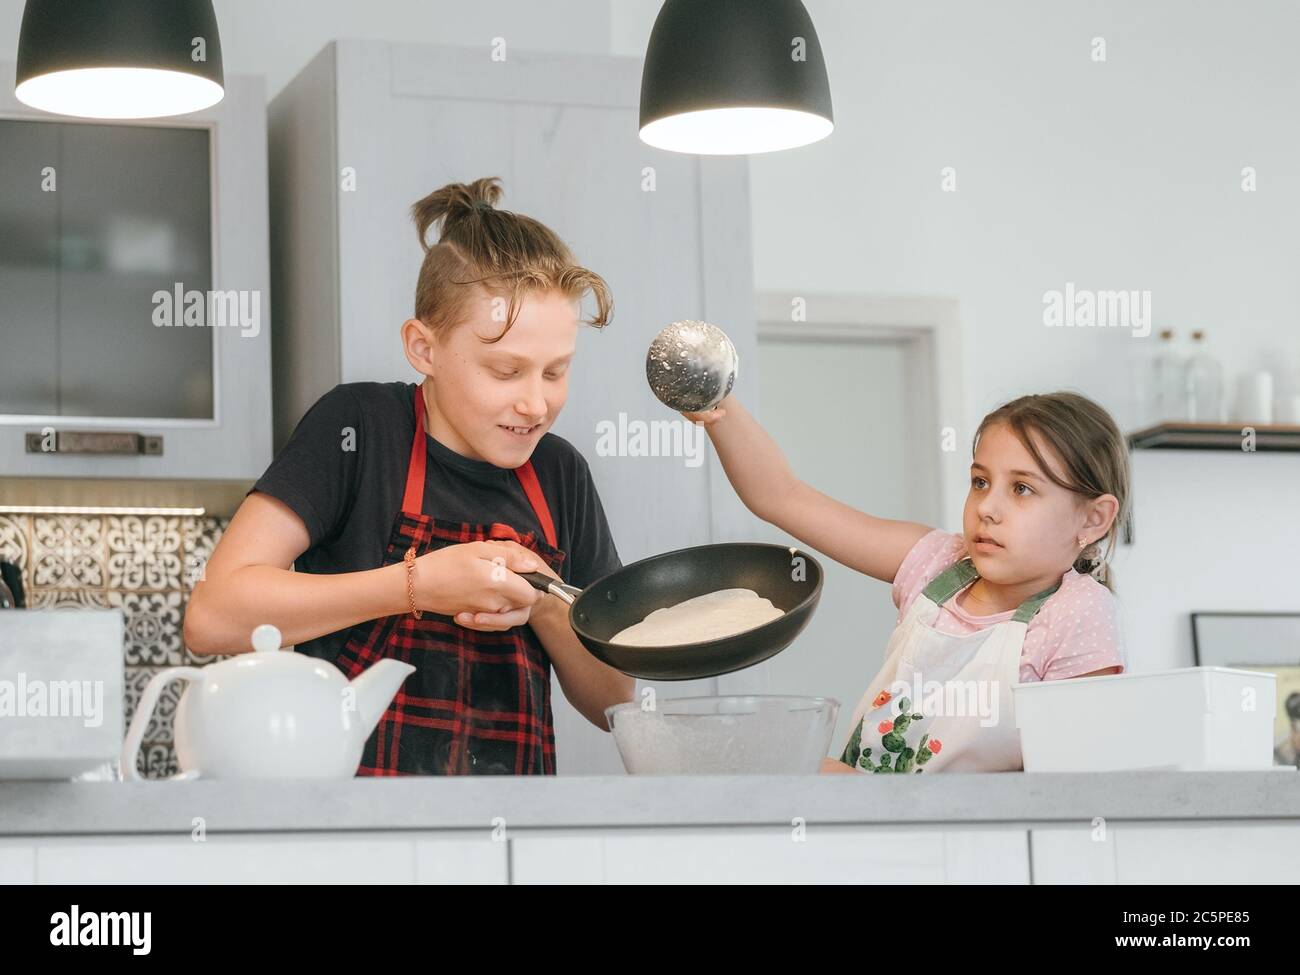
(411, 177), (614, 342)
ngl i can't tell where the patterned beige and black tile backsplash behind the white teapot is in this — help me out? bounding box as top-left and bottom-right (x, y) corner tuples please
(0, 515), (228, 779)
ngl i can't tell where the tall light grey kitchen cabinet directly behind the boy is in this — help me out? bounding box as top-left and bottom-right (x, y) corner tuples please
(269, 40), (757, 775)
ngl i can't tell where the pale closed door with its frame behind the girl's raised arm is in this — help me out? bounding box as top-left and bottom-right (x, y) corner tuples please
(720, 295), (965, 754)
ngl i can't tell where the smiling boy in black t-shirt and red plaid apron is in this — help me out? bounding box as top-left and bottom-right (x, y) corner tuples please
(185, 178), (633, 775)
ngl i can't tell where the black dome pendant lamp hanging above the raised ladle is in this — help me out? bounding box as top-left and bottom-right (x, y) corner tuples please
(641, 0), (835, 155)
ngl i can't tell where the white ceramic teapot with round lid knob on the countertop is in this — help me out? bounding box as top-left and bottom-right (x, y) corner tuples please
(122, 624), (415, 780)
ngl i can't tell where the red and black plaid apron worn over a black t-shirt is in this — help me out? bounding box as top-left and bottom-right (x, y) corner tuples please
(337, 386), (564, 775)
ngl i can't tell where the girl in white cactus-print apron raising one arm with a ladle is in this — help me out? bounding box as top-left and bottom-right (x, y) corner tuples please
(684, 393), (1128, 772)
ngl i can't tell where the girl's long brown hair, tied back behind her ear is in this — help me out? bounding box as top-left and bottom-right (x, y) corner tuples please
(971, 393), (1132, 592)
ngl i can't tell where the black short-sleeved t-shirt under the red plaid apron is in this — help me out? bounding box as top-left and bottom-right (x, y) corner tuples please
(250, 382), (621, 662)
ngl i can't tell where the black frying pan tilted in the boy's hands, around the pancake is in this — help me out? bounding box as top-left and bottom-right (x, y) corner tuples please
(519, 542), (822, 680)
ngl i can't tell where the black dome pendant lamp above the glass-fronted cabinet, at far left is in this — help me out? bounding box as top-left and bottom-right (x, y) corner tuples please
(14, 0), (225, 118)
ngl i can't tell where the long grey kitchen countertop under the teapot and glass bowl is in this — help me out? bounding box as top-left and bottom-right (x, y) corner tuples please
(0, 770), (1300, 837)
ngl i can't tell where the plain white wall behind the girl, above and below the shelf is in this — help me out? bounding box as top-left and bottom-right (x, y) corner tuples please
(611, 0), (1300, 671)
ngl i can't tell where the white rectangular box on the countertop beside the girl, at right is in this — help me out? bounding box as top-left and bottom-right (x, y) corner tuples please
(1011, 667), (1277, 772)
